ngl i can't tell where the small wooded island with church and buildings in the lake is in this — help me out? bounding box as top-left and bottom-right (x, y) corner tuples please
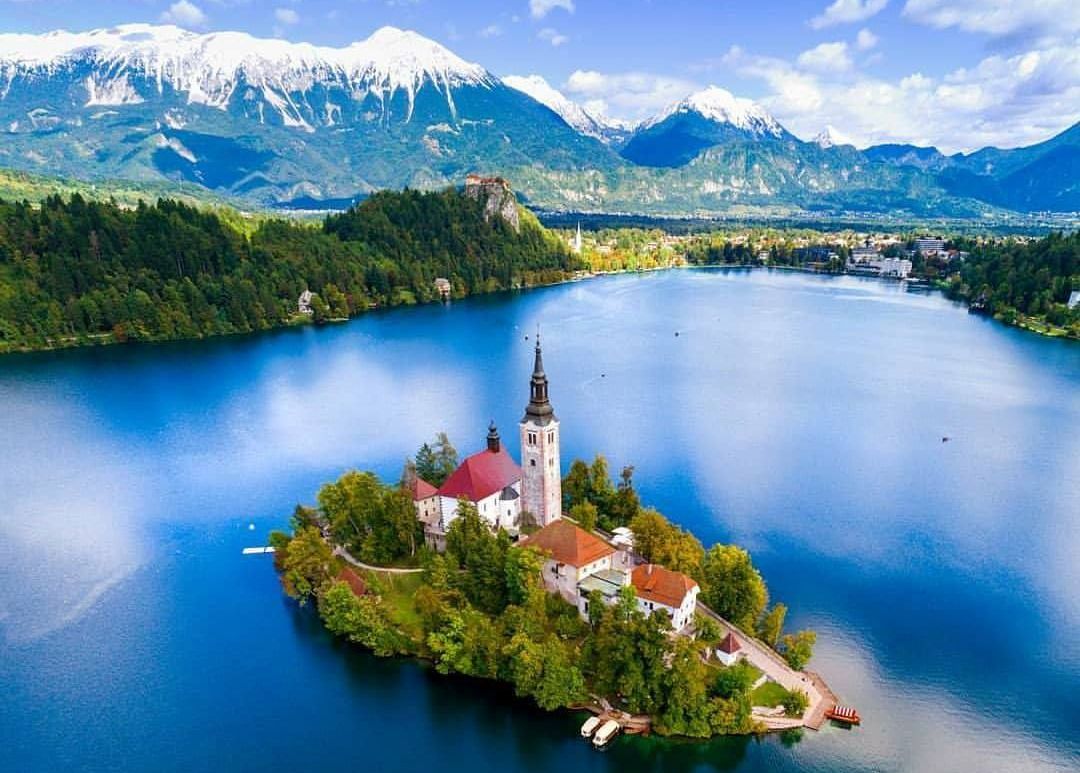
(270, 334), (837, 738)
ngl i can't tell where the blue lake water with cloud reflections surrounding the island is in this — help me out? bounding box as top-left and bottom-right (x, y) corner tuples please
(0, 271), (1080, 771)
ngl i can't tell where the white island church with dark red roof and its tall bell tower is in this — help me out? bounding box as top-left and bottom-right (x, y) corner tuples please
(413, 335), (563, 551)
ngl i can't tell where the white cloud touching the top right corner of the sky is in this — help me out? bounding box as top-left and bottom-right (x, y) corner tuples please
(904, 0), (1080, 44)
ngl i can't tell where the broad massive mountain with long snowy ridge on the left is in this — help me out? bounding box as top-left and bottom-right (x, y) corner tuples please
(0, 25), (619, 203)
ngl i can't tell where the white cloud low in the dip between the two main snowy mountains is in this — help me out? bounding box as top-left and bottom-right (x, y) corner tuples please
(563, 70), (701, 121)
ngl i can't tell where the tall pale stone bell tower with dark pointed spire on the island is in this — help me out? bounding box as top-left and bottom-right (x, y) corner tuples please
(522, 333), (563, 526)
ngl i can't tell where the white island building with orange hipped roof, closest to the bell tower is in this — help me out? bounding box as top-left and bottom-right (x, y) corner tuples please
(522, 518), (616, 606)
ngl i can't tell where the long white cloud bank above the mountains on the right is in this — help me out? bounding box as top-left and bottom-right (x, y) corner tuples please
(724, 44), (1080, 152)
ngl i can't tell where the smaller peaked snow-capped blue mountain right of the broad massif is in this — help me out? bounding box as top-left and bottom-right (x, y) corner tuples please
(621, 86), (792, 167)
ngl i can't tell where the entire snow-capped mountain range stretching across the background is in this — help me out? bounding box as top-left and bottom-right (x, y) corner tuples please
(0, 24), (1080, 217)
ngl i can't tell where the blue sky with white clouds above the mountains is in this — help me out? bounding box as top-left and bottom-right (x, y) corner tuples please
(0, 0), (1080, 152)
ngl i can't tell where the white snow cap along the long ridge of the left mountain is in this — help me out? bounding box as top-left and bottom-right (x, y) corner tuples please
(0, 24), (495, 118)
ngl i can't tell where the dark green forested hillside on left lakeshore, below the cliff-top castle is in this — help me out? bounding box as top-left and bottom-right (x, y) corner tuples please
(0, 190), (577, 351)
